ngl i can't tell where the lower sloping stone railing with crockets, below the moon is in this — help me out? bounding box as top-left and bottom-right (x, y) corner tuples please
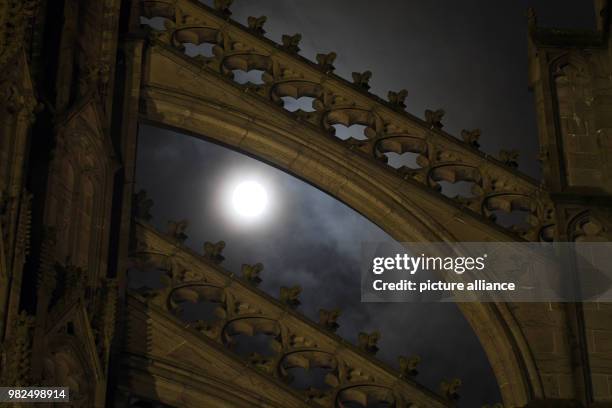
(132, 222), (460, 407)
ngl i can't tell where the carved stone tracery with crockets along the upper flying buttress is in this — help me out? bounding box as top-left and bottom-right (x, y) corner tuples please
(142, 0), (555, 240)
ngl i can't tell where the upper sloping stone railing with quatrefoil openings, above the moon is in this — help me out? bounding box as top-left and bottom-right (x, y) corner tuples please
(140, 0), (554, 241)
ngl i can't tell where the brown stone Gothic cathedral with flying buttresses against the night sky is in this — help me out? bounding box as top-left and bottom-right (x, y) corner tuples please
(0, 0), (612, 408)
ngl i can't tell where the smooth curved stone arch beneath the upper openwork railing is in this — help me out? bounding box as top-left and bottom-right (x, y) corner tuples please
(141, 50), (543, 407)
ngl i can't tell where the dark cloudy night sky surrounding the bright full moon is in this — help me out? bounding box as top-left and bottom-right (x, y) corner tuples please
(137, 0), (594, 407)
